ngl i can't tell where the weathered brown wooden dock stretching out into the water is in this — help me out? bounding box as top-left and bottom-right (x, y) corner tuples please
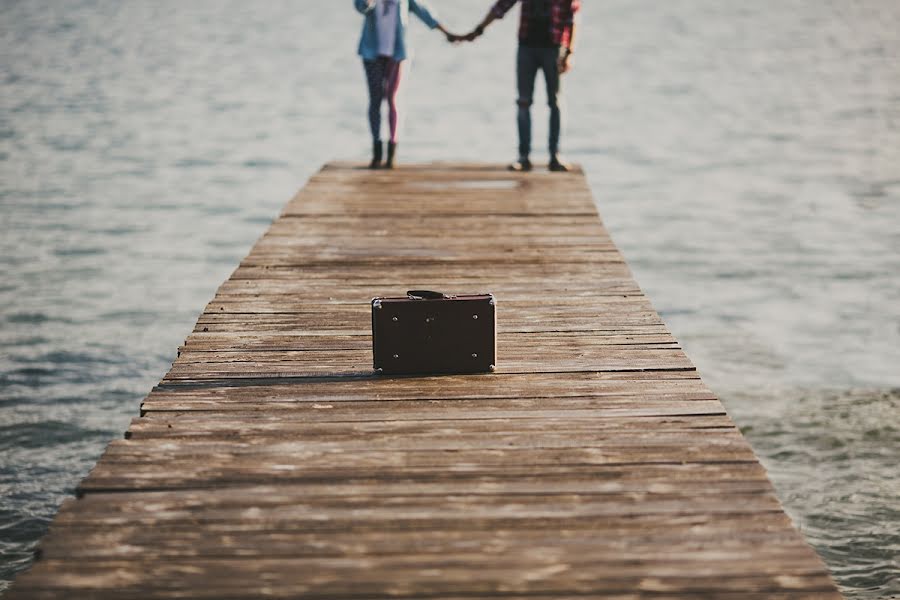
(8, 164), (840, 600)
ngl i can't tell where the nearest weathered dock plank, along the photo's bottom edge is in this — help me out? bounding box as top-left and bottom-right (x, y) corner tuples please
(7, 551), (839, 598)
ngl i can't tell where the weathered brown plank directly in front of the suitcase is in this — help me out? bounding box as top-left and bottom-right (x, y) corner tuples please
(144, 371), (724, 412)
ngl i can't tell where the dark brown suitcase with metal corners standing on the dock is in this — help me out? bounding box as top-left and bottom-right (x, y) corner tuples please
(372, 291), (497, 374)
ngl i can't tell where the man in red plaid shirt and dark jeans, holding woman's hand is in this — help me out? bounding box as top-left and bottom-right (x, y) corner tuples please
(466, 0), (581, 171)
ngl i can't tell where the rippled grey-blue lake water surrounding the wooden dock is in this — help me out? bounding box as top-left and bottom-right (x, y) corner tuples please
(0, 0), (900, 598)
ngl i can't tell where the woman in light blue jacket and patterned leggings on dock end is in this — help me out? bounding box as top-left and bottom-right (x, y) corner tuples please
(353, 0), (461, 169)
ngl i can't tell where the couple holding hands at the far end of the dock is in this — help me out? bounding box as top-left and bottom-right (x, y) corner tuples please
(353, 0), (581, 171)
